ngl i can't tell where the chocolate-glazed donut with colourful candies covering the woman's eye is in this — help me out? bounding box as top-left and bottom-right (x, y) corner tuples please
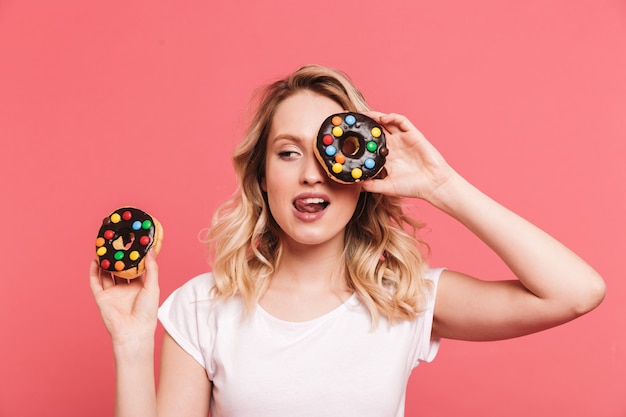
(315, 112), (389, 184)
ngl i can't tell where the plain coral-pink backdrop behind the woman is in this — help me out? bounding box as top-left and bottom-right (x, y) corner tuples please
(0, 0), (626, 417)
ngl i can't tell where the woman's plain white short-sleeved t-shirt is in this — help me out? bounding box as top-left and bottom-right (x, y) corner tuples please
(159, 269), (441, 417)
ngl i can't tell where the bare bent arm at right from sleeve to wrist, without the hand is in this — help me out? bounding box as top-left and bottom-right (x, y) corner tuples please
(431, 176), (605, 340)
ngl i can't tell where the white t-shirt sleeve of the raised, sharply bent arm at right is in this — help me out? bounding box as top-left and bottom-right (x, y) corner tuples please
(413, 268), (444, 366)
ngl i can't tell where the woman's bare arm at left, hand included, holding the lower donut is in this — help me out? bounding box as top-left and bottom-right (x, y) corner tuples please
(89, 252), (211, 417)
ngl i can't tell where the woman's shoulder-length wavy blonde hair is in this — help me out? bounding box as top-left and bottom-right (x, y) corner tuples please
(208, 65), (430, 325)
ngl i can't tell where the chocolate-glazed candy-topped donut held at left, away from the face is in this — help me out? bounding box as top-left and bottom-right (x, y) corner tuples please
(96, 207), (163, 279)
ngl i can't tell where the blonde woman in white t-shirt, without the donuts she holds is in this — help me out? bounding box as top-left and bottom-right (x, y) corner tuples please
(90, 66), (605, 417)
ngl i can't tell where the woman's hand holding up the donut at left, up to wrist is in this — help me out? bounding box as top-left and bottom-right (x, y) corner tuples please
(89, 250), (159, 345)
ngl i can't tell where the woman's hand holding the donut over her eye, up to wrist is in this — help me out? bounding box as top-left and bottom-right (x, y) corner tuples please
(362, 112), (456, 201)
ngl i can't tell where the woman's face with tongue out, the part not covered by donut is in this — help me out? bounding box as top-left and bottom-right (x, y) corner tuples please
(262, 90), (361, 247)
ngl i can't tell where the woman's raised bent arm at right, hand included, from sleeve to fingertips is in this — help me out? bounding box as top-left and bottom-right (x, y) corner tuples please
(363, 113), (605, 340)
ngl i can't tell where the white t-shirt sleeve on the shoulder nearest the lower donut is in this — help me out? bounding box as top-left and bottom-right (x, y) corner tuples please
(158, 274), (213, 369)
